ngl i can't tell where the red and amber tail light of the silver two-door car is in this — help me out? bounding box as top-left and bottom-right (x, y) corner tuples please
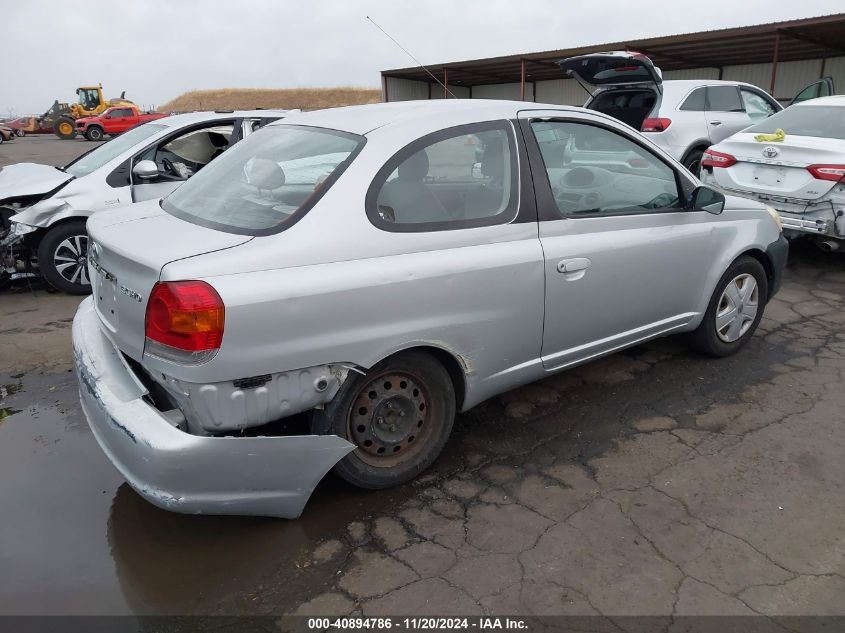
(144, 281), (225, 364)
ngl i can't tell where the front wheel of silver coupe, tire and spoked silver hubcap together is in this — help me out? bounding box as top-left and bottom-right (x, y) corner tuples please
(689, 255), (769, 357)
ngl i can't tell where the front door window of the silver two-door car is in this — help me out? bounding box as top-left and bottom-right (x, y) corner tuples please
(531, 121), (681, 217)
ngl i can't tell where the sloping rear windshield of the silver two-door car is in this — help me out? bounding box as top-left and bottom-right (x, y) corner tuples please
(162, 125), (365, 235)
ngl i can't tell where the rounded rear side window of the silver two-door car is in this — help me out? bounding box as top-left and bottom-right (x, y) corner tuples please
(366, 121), (518, 232)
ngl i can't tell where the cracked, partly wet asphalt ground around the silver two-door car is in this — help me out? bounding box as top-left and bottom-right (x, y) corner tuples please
(0, 137), (845, 617)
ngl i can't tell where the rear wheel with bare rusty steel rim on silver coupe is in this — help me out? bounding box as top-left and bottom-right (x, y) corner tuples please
(311, 351), (455, 490)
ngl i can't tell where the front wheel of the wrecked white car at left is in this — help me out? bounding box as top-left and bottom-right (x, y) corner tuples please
(38, 220), (91, 295)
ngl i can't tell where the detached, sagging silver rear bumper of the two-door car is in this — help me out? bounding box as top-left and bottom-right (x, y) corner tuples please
(68, 298), (354, 518)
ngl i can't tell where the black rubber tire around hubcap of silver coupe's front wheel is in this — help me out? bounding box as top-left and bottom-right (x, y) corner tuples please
(688, 255), (769, 357)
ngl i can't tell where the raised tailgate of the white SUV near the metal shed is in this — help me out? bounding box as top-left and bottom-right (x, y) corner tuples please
(557, 51), (663, 92)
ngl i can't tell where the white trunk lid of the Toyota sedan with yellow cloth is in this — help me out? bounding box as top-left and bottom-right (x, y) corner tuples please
(712, 132), (845, 201)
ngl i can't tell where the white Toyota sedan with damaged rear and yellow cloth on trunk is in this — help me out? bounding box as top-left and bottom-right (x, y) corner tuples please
(701, 96), (845, 251)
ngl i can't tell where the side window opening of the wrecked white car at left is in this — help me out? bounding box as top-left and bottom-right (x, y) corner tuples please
(136, 121), (234, 180)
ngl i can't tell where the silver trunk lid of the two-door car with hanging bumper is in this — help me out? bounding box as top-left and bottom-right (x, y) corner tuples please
(88, 200), (252, 362)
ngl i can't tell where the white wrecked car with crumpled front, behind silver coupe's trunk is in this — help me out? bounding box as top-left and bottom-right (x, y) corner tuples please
(0, 110), (296, 294)
